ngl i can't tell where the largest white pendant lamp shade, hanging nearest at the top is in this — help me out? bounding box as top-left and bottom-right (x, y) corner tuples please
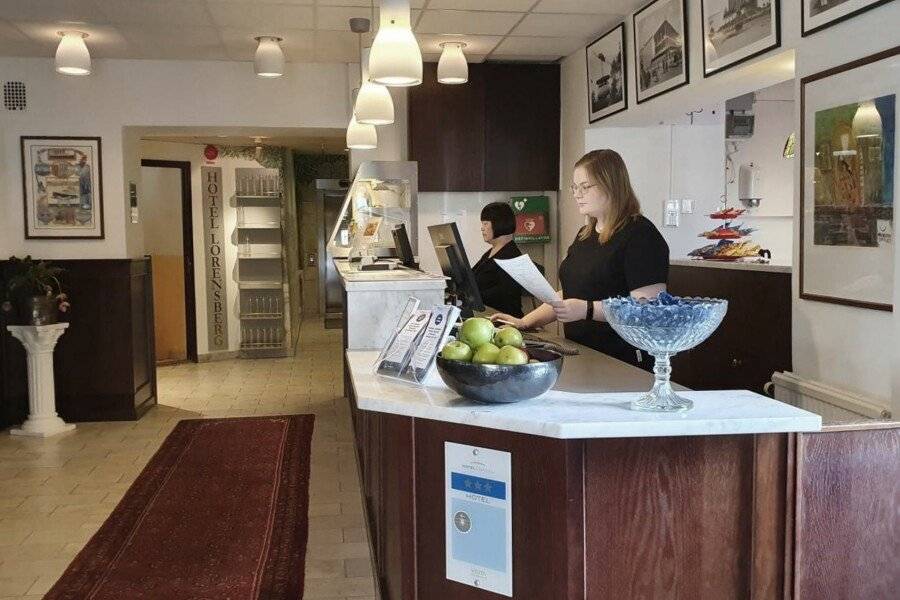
(369, 0), (422, 87)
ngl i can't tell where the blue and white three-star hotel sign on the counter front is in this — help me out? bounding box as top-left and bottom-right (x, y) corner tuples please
(444, 442), (512, 598)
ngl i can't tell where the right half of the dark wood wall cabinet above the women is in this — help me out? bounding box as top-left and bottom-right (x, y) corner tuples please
(482, 63), (560, 191)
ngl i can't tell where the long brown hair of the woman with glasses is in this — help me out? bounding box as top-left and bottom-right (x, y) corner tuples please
(575, 149), (641, 243)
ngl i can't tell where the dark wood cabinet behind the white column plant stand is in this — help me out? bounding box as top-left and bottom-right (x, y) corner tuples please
(0, 257), (156, 425)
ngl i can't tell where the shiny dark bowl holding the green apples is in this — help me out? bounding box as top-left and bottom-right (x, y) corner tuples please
(437, 348), (562, 404)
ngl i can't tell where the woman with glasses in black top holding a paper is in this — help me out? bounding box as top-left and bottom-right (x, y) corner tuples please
(492, 150), (669, 370)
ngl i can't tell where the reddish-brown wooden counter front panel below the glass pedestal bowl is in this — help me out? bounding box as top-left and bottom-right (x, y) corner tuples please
(584, 435), (754, 600)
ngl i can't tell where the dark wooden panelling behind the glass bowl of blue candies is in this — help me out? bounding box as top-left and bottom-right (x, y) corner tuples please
(669, 265), (791, 393)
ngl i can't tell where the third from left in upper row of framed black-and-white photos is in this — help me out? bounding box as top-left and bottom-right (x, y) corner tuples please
(700, 0), (781, 77)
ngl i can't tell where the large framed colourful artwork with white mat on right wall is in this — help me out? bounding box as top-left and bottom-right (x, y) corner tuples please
(800, 46), (900, 311)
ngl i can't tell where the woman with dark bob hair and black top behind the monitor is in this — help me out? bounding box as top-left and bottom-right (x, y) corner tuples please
(472, 202), (523, 317)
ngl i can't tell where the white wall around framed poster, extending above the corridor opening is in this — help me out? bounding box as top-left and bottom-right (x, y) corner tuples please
(0, 58), (352, 259)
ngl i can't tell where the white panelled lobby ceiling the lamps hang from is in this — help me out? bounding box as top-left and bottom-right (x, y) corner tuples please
(0, 0), (646, 62)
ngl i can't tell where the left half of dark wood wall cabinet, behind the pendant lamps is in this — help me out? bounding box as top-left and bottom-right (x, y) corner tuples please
(412, 63), (488, 190)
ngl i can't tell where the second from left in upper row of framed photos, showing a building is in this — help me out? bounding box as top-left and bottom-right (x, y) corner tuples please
(632, 0), (690, 104)
